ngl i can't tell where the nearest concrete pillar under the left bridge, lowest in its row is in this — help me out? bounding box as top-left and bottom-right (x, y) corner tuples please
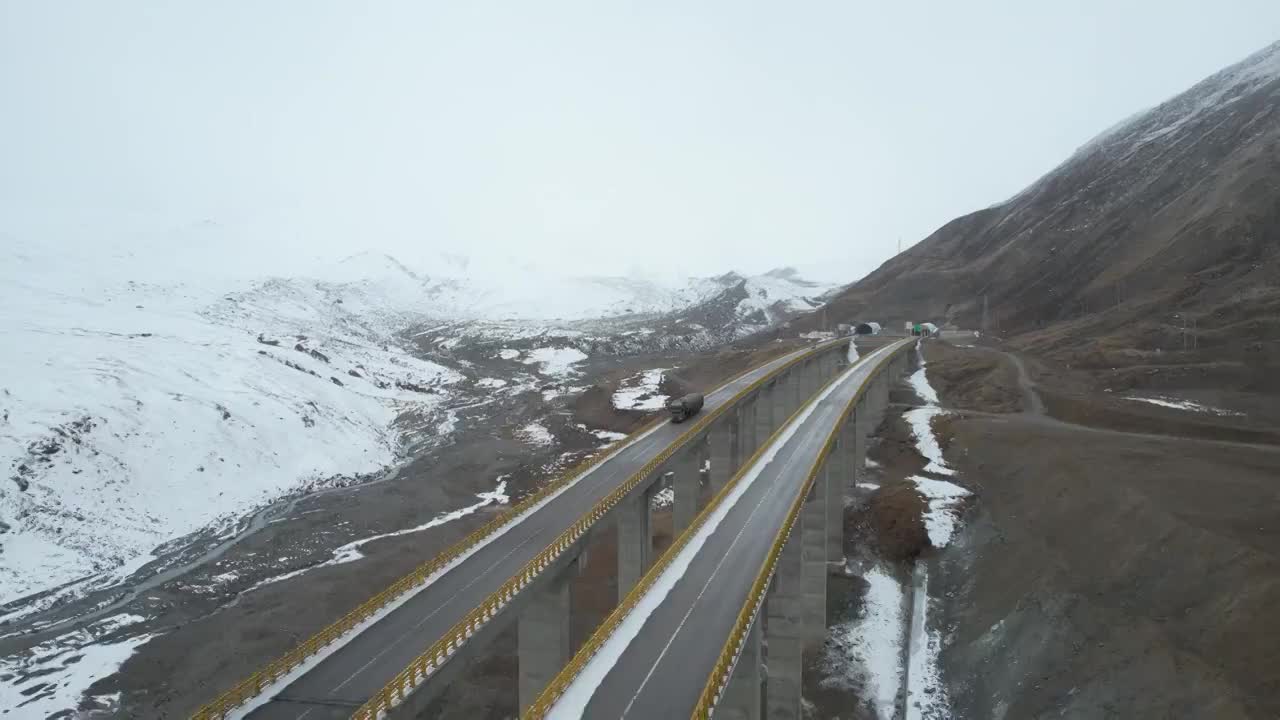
(516, 561), (577, 710)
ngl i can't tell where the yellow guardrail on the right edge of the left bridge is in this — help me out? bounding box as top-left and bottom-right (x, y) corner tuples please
(352, 341), (844, 720)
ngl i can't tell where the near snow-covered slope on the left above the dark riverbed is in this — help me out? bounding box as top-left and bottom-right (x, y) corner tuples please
(0, 245), (460, 603)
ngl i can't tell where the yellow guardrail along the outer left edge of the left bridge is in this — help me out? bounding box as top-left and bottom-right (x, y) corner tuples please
(192, 343), (829, 720)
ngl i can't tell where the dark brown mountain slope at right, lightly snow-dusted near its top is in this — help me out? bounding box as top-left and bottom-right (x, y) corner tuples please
(808, 44), (1280, 391)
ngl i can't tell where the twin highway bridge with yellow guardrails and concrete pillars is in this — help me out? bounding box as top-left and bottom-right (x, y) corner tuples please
(195, 338), (909, 720)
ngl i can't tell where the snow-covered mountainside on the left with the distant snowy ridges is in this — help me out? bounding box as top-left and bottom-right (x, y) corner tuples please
(0, 238), (829, 607)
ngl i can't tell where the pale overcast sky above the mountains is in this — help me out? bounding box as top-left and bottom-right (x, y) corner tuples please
(0, 0), (1280, 279)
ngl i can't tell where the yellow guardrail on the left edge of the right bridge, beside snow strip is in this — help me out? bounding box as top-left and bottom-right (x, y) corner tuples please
(522, 338), (890, 720)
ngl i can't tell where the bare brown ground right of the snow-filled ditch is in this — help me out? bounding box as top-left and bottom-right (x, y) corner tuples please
(929, 343), (1280, 717)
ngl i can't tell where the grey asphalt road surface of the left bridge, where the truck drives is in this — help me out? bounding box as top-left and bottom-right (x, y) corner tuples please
(234, 338), (829, 720)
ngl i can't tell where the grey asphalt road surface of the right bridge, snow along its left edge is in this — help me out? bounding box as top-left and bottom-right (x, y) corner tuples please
(549, 341), (909, 720)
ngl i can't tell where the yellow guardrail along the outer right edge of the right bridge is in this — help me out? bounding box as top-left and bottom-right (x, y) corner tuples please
(692, 342), (910, 720)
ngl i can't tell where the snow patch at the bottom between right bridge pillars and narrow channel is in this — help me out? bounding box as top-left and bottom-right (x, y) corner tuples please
(823, 566), (906, 720)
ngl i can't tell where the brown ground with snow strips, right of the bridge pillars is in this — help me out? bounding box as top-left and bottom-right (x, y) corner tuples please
(805, 340), (1280, 720)
